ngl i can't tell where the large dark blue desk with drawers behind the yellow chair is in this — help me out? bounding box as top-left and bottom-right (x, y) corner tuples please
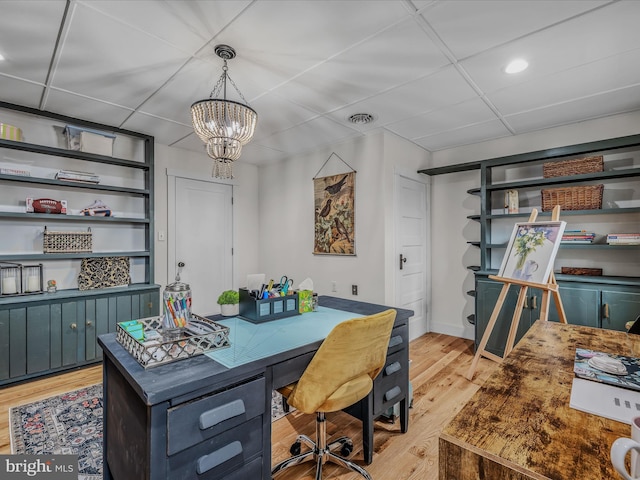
(98, 296), (413, 480)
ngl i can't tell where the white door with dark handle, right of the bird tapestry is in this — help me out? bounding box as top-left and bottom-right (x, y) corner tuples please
(395, 174), (429, 339)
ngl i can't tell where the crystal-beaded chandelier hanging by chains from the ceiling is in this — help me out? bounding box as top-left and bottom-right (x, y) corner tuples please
(191, 45), (258, 178)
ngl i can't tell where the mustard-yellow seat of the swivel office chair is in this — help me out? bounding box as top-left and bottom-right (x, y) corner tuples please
(278, 374), (373, 413)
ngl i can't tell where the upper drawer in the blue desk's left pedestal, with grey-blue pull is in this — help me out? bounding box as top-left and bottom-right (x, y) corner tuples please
(167, 378), (266, 455)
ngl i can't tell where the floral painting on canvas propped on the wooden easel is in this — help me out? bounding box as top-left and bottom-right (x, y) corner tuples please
(498, 222), (566, 284)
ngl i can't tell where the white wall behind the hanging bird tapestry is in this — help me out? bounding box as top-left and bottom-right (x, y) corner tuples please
(259, 132), (428, 322)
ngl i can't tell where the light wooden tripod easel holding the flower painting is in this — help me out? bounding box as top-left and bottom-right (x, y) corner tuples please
(466, 205), (567, 380)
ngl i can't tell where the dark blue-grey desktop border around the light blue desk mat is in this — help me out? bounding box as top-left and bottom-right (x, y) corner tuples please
(98, 296), (413, 405)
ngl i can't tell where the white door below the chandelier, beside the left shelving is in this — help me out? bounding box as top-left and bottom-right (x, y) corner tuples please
(168, 177), (233, 315)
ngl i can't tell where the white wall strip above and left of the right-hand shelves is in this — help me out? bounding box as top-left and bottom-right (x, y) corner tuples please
(430, 112), (640, 338)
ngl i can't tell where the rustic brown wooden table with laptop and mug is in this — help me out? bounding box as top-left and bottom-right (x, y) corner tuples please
(439, 321), (640, 480)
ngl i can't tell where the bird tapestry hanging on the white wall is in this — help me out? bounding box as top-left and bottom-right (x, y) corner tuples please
(313, 172), (356, 255)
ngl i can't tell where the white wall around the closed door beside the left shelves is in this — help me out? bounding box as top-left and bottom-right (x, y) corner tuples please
(154, 144), (260, 288)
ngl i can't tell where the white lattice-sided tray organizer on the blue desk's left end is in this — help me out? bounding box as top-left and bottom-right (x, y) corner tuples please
(116, 313), (231, 369)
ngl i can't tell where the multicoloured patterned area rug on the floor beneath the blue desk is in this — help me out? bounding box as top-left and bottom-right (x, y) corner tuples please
(9, 384), (294, 480)
